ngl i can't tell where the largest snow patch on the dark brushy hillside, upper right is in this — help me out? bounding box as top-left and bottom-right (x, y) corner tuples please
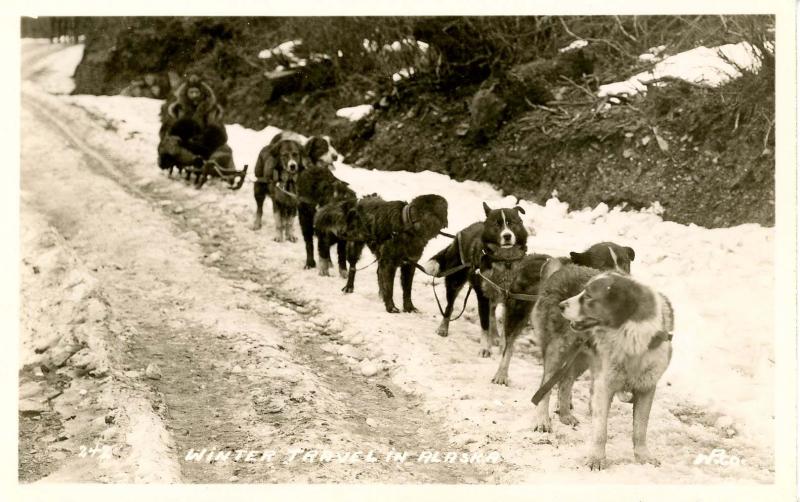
(597, 42), (761, 98)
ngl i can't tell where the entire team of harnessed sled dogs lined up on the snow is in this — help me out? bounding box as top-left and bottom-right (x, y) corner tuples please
(248, 132), (673, 470)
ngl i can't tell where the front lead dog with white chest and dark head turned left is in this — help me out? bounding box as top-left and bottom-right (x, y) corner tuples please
(534, 265), (674, 470)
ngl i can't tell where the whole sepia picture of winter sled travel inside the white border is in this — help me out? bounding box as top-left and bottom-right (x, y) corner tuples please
(9, 5), (796, 500)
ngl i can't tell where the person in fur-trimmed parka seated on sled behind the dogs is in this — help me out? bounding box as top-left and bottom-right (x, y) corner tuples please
(158, 75), (244, 188)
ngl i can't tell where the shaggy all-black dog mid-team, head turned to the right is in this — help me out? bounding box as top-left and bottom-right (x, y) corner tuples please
(345, 194), (447, 313)
